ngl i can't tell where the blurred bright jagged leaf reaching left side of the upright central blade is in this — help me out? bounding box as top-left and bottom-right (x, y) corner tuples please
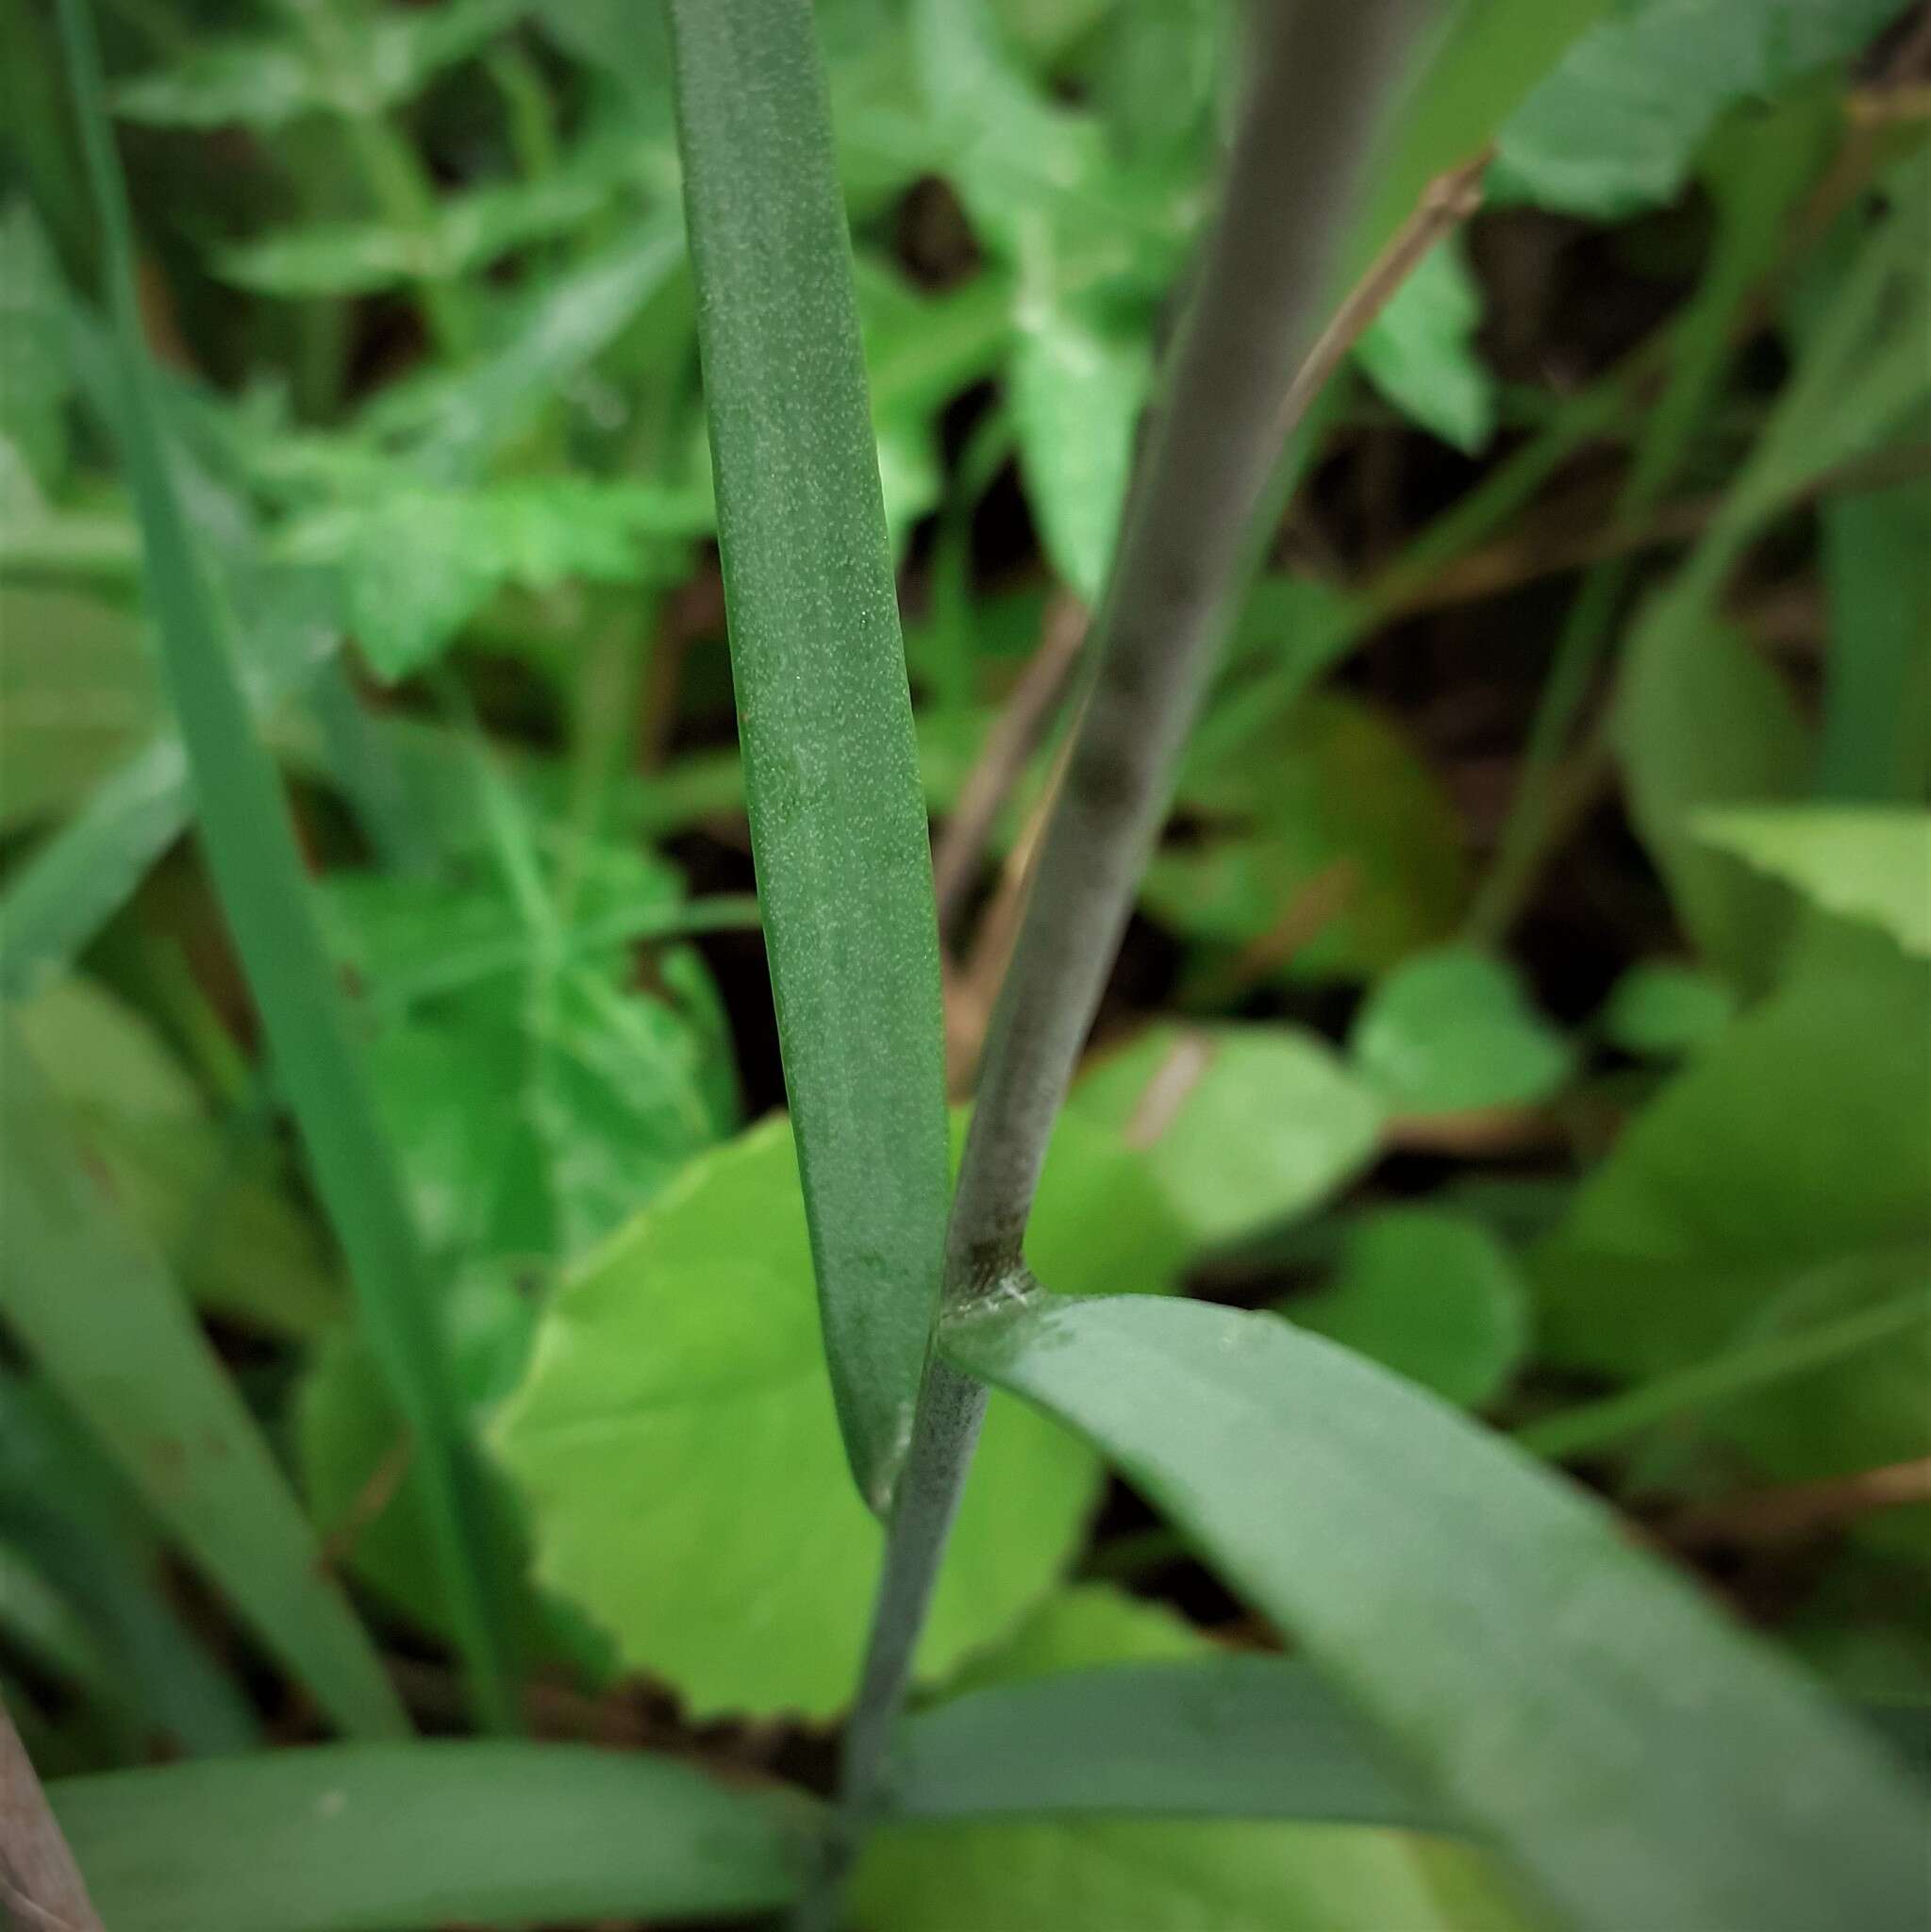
(282, 477), (710, 678)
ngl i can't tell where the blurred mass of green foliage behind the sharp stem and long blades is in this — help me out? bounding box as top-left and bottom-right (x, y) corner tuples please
(0, 0), (1931, 1926)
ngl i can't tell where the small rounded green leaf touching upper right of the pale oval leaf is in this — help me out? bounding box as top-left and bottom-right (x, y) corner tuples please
(1348, 947), (1575, 1115)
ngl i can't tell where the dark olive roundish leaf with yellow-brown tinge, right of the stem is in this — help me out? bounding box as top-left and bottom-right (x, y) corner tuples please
(1141, 691), (1468, 977)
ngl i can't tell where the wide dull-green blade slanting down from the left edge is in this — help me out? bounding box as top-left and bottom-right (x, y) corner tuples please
(0, 1020), (406, 1737)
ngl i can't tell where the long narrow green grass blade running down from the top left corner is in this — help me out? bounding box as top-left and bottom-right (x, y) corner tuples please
(59, 0), (514, 1725)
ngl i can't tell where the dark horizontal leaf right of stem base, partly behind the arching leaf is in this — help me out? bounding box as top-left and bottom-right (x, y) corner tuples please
(885, 1656), (1460, 1832)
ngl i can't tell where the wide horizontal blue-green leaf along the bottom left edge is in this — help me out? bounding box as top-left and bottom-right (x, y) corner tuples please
(48, 1742), (815, 1932)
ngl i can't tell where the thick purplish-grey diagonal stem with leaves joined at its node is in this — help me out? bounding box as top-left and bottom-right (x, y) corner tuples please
(799, 0), (1423, 1928)
